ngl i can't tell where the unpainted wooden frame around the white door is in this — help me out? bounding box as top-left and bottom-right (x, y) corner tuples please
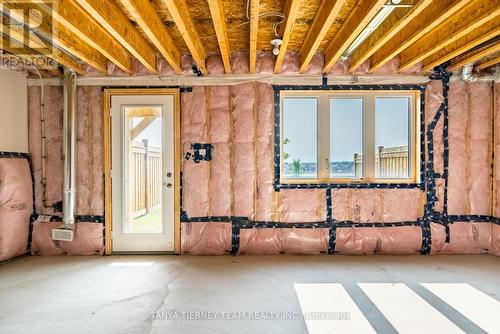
(103, 88), (181, 255)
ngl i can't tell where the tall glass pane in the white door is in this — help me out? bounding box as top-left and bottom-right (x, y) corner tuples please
(123, 106), (163, 233)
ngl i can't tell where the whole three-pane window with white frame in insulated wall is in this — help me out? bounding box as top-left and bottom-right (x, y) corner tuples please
(280, 90), (420, 183)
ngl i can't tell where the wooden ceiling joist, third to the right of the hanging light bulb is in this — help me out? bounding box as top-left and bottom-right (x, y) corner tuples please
(323, 0), (387, 73)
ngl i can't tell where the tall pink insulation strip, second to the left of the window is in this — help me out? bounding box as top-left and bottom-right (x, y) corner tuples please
(231, 83), (256, 217)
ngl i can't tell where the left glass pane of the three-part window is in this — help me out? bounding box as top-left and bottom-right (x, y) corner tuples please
(281, 98), (318, 179)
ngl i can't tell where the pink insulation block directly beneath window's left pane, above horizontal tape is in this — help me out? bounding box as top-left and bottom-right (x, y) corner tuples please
(279, 189), (326, 223)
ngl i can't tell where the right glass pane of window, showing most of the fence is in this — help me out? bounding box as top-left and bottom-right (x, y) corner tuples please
(375, 97), (410, 179)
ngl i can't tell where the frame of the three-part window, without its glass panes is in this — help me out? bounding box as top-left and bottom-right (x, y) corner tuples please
(280, 90), (422, 184)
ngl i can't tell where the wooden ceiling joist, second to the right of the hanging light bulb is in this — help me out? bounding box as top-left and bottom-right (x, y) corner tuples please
(299, 0), (347, 73)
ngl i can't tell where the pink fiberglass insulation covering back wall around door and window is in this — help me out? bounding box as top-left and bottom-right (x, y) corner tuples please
(18, 54), (500, 255)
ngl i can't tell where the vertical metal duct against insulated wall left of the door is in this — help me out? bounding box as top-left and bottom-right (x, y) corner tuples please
(62, 71), (76, 229)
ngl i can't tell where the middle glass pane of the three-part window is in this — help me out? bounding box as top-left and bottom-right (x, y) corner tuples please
(330, 98), (363, 179)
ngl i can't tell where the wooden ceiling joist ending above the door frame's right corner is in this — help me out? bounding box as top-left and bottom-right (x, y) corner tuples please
(119, 0), (182, 74)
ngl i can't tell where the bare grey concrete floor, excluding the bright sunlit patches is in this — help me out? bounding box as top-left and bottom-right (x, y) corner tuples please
(0, 255), (500, 334)
